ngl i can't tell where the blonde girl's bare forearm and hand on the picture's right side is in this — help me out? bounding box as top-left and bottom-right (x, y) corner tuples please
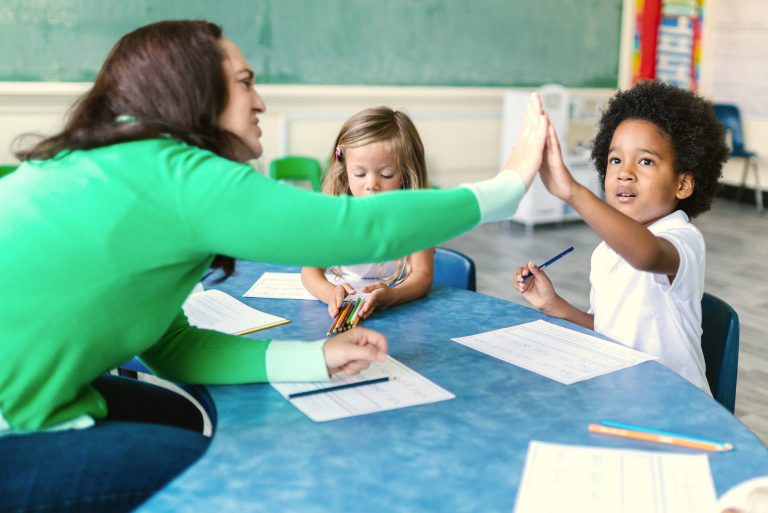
(360, 248), (435, 319)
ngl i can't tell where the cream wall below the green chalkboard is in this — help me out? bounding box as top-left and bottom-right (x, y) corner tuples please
(0, 82), (611, 187)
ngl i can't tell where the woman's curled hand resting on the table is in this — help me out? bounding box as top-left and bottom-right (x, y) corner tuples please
(323, 328), (387, 374)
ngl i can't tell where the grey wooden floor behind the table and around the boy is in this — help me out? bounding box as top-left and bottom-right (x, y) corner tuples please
(446, 198), (768, 444)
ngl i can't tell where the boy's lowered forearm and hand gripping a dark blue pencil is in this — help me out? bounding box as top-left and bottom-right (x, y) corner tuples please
(514, 262), (595, 330)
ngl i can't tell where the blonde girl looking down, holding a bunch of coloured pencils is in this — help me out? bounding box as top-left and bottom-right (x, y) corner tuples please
(301, 107), (435, 319)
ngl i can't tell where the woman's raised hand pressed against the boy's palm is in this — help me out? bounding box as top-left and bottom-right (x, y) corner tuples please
(504, 93), (549, 187)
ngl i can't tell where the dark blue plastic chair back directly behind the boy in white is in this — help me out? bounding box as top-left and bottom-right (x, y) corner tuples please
(701, 292), (739, 413)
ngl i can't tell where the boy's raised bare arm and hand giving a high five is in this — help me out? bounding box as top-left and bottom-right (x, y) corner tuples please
(541, 125), (680, 279)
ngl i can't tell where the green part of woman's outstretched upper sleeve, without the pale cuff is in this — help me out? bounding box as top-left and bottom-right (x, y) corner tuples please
(165, 143), (481, 267)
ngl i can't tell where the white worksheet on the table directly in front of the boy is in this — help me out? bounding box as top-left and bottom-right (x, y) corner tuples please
(452, 320), (656, 385)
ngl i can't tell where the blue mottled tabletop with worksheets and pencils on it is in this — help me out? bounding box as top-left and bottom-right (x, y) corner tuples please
(139, 262), (768, 513)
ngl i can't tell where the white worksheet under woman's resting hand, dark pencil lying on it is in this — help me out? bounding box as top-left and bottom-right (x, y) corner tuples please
(272, 356), (456, 422)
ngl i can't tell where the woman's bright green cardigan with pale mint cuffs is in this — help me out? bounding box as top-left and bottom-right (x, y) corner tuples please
(0, 139), (525, 432)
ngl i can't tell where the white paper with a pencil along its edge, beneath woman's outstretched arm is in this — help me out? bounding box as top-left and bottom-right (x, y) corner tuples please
(184, 289), (290, 335)
